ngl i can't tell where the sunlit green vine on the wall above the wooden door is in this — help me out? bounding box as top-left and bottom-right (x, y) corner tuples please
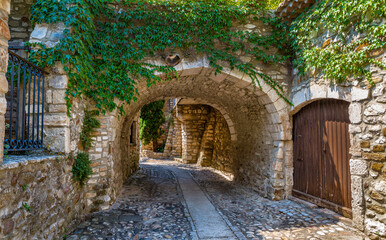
(290, 0), (386, 84)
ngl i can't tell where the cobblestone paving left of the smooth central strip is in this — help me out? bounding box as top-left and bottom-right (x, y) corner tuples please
(66, 167), (195, 240)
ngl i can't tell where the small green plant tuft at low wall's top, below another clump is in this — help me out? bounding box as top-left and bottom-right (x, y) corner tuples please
(72, 152), (92, 186)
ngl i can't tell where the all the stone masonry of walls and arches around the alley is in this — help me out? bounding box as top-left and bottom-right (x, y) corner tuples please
(0, 0), (386, 239)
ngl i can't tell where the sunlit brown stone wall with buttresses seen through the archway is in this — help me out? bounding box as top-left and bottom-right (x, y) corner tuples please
(165, 104), (237, 173)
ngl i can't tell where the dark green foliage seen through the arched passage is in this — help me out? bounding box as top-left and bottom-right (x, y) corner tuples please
(139, 100), (165, 146)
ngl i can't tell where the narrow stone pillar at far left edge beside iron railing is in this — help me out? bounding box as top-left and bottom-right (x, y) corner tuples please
(0, 0), (11, 164)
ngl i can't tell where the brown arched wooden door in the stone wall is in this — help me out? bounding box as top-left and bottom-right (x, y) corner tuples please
(293, 99), (351, 217)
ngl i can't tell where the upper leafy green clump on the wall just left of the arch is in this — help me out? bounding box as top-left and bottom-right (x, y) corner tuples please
(80, 110), (101, 150)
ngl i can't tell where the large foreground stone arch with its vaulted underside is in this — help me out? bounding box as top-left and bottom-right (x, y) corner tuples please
(83, 58), (292, 208)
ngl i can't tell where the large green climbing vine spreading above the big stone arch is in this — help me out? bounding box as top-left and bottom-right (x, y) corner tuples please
(30, 0), (288, 115)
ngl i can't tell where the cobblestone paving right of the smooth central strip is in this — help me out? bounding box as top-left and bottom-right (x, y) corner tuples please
(188, 165), (367, 240)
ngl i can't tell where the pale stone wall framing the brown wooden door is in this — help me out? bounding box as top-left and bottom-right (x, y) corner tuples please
(291, 34), (386, 239)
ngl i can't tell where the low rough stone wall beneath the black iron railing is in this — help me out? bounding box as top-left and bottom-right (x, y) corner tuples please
(0, 156), (88, 239)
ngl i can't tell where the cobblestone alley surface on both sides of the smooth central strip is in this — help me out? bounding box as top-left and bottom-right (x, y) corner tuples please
(67, 159), (367, 240)
